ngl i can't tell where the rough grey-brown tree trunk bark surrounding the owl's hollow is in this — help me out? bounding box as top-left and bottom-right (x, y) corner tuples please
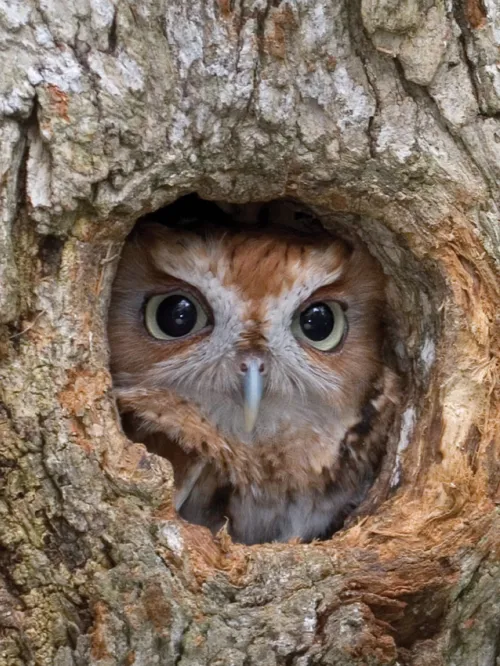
(0, 0), (500, 666)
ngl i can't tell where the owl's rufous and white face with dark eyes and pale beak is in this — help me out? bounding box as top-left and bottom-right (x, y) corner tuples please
(109, 224), (383, 442)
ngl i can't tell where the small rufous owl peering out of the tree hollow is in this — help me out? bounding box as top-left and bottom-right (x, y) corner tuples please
(109, 215), (395, 544)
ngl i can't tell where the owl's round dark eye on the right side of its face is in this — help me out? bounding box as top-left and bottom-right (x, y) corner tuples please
(292, 301), (347, 351)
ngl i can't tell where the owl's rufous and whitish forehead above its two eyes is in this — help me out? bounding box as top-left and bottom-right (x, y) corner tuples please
(147, 230), (349, 300)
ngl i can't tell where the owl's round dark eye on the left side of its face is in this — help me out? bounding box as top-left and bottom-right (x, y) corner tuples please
(144, 291), (208, 340)
